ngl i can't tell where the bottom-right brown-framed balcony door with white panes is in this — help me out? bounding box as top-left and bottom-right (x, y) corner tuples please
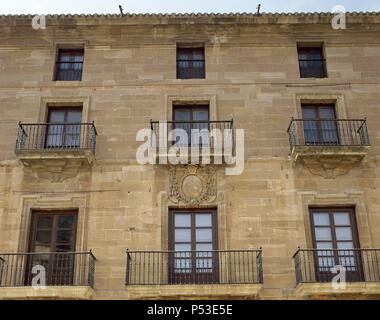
(310, 208), (363, 282)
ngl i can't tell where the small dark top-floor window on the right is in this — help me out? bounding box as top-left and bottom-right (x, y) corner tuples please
(297, 46), (327, 78)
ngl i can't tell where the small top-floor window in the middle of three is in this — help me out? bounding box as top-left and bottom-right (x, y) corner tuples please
(177, 46), (206, 79)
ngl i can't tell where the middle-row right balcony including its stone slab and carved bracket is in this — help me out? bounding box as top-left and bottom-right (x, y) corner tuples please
(288, 119), (370, 178)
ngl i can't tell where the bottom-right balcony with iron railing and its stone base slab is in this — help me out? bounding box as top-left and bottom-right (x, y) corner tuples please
(293, 249), (380, 297)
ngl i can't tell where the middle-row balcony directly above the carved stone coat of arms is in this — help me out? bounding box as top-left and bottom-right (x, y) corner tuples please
(150, 120), (235, 164)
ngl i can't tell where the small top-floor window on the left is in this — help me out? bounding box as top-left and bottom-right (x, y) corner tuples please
(54, 49), (84, 81)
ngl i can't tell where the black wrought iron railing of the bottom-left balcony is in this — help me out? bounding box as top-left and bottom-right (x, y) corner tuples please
(0, 251), (96, 287)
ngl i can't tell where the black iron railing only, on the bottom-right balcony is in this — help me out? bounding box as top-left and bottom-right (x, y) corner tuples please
(293, 249), (380, 284)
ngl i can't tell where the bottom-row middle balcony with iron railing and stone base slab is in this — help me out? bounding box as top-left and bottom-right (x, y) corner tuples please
(126, 249), (263, 299)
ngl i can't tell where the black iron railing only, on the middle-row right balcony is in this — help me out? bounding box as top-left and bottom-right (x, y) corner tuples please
(288, 119), (370, 149)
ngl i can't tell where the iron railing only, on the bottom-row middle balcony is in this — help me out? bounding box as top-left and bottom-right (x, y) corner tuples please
(126, 249), (263, 285)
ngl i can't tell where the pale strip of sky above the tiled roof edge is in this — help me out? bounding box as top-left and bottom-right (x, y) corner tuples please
(0, 0), (380, 14)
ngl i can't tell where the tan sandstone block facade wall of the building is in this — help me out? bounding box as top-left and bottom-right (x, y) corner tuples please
(0, 13), (380, 299)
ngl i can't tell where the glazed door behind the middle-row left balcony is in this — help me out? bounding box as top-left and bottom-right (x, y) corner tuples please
(45, 107), (82, 149)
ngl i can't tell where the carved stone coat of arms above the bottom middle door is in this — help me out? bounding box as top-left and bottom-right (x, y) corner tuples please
(169, 165), (217, 205)
